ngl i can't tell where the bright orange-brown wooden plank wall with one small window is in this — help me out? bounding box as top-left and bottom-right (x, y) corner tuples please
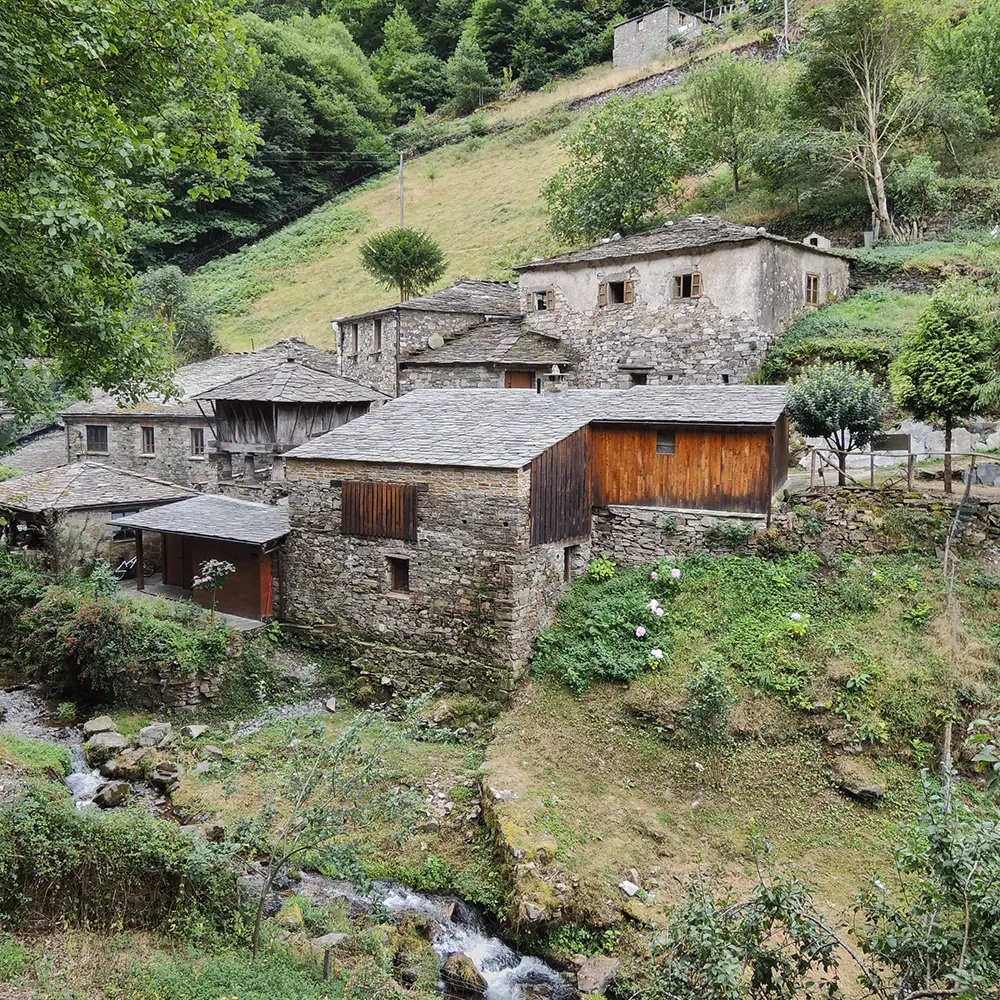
(590, 424), (774, 513)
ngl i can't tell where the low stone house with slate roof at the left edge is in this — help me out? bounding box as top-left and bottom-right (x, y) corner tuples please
(0, 462), (192, 572)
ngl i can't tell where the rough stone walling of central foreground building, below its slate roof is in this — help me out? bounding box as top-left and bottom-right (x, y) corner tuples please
(282, 459), (589, 697)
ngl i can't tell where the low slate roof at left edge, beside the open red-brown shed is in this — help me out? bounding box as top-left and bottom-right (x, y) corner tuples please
(0, 462), (193, 514)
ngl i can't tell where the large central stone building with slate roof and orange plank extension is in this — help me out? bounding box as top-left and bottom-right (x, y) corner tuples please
(282, 383), (788, 695)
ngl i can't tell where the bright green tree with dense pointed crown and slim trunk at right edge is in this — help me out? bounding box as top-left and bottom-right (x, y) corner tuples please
(889, 279), (998, 493)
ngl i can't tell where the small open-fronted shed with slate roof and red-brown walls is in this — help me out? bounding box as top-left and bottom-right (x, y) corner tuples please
(114, 494), (288, 620)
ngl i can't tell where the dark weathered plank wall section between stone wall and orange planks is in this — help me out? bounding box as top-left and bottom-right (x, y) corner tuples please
(531, 428), (591, 545)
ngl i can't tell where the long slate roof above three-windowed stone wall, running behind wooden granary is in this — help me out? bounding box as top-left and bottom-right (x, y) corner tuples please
(63, 337), (337, 417)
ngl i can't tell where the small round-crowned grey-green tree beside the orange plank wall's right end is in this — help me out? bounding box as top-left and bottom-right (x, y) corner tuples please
(788, 361), (889, 486)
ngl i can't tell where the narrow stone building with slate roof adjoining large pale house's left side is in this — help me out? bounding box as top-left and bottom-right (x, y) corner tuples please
(333, 279), (520, 396)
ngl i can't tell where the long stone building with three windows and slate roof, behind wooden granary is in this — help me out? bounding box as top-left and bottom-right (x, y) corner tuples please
(63, 337), (350, 490)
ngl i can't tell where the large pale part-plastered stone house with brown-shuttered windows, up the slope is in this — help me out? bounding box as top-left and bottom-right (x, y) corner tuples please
(518, 216), (849, 388)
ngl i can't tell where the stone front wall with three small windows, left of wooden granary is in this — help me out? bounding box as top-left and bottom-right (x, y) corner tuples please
(64, 413), (216, 489)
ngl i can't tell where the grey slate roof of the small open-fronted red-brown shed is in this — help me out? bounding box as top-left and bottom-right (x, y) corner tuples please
(115, 493), (289, 545)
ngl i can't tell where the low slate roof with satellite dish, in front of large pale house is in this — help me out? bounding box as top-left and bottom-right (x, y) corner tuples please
(402, 320), (579, 367)
